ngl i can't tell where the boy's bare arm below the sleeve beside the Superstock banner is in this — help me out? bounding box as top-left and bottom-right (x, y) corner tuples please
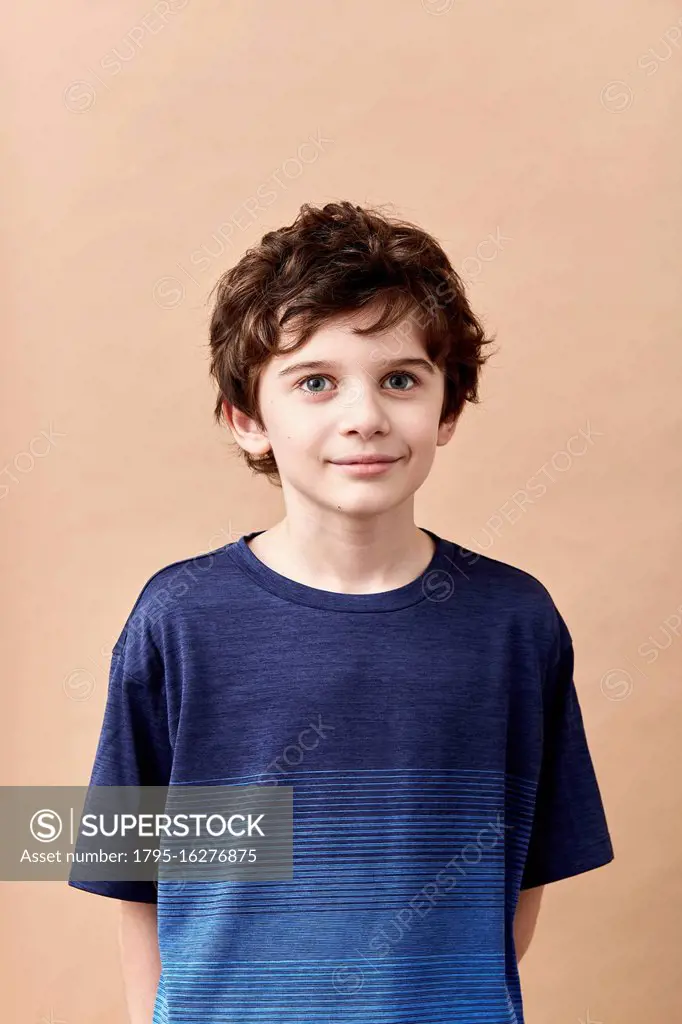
(119, 900), (161, 1024)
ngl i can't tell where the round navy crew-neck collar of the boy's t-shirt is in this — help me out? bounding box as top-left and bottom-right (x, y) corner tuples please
(227, 526), (455, 611)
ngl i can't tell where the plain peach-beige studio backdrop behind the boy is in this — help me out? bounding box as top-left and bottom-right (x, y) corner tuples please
(0, 0), (682, 1024)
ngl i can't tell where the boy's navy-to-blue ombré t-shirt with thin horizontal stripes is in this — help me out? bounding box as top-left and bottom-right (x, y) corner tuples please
(70, 529), (613, 1024)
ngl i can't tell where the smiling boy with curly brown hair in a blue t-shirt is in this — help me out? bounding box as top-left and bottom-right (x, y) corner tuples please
(71, 203), (613, 1024)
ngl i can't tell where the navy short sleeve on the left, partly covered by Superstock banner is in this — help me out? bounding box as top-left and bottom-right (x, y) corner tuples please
(69, 598), (172, 903)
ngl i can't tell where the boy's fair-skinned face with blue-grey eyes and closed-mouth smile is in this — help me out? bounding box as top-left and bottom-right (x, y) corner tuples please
(225, 301), (456, 516)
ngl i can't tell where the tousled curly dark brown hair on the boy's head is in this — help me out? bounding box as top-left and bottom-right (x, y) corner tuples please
(209, 202), (495, 484)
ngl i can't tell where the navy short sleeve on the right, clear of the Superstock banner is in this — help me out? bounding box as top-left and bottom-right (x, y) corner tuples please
(520, 609), (613, 889)
